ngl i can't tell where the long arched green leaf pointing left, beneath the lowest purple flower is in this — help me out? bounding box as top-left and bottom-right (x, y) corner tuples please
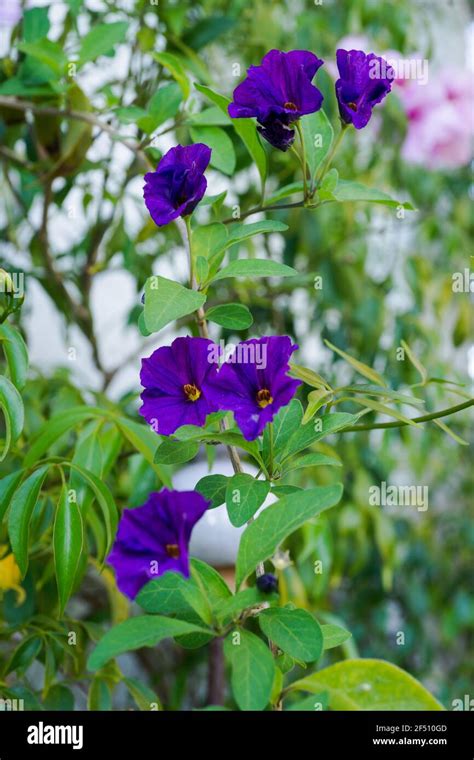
(87, 615), (211, 670)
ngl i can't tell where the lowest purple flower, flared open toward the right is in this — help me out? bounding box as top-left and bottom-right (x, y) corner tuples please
(108, 489), (211, 599)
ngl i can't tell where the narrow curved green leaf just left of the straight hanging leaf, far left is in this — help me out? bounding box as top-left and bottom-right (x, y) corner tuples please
(8, 465), (49, 577)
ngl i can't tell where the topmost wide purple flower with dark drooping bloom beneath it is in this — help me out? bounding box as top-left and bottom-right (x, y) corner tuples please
(229, 50), (323, 150)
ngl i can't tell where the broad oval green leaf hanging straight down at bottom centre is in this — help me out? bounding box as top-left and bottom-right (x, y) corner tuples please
(224, 630), (275, 710)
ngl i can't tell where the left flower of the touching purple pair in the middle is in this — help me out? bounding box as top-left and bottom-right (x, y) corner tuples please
(140, 337), (217, 435)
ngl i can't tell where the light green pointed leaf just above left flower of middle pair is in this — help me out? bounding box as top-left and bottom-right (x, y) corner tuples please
(144, 276), (206, 332)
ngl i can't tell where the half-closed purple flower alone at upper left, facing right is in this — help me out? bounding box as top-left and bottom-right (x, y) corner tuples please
(143, 143), (211, 227)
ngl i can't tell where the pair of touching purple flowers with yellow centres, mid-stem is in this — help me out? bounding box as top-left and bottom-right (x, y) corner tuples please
(140, 336), (300, 441)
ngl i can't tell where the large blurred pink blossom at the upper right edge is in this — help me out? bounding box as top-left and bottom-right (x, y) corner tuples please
(399, 68), (474, 170)
